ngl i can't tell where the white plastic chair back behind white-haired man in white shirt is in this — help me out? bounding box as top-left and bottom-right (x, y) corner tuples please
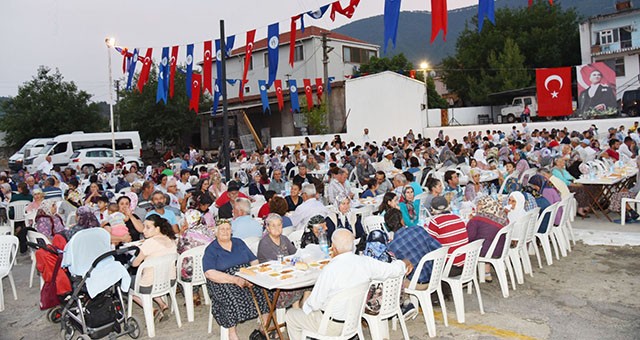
(318, 282), (369, 338)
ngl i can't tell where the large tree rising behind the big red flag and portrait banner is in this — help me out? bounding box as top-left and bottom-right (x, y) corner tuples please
(442, 0), (581, 104)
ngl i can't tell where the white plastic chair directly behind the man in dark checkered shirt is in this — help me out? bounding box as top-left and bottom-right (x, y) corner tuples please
(404, 247), (449, 338)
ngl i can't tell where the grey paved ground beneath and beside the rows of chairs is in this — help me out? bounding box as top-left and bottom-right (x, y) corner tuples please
(0, 218), (640, 340)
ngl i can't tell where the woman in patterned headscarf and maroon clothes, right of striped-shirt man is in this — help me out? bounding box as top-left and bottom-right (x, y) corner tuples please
(467, 196), (509, 282)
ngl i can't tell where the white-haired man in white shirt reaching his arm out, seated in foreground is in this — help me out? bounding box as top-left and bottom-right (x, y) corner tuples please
(286, 229), (413, 340)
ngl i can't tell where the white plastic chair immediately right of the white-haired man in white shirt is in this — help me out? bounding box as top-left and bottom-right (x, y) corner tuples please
(362, 273), (409, 340)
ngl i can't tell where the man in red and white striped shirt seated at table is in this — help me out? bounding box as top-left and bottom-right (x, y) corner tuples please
(427, 196), (469, 276)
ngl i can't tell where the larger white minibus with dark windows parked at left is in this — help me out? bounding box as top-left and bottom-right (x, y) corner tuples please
(24, 131), (142, 173)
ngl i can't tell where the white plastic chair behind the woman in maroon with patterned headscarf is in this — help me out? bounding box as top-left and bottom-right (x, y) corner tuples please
(478, 223), (516, 298)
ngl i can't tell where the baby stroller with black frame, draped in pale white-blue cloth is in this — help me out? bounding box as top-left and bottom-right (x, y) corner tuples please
(60, 228), (140, 340)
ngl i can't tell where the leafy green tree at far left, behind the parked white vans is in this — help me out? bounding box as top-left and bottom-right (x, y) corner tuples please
(0, 66), (108, 147)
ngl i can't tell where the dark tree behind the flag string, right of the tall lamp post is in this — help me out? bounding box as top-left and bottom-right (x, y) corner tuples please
(116, 67), (211, 147)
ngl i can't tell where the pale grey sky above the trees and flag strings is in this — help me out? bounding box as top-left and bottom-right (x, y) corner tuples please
(0, 0), (478, 101)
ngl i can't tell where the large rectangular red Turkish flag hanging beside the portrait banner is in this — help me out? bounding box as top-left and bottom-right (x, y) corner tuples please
(536, 67), (573, 117)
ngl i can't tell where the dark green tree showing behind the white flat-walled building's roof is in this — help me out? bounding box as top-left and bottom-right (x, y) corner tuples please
(355, 53), (449, 109)
